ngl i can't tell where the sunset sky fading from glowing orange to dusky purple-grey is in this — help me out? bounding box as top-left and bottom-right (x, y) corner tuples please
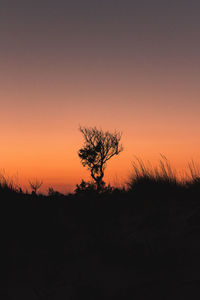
(0, 0), (200, 192)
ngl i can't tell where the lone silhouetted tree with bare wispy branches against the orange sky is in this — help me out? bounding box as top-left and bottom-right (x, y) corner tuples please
(78, 127), (123, 191)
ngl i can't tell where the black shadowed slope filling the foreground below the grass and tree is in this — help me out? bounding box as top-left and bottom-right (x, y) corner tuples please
(0, 186), (200, 300)
